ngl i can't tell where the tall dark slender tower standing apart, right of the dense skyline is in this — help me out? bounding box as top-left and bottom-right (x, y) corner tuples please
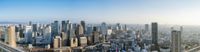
(151, 22), (159, 51)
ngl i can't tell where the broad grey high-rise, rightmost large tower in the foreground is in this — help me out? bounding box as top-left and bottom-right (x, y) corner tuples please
(171, 30), (181, 52)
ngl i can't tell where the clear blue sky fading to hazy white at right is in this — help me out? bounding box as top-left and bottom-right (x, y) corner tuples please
(0, 0), (200, 25)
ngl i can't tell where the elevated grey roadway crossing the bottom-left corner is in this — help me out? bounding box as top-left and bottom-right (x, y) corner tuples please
(0, 41), (25, 52)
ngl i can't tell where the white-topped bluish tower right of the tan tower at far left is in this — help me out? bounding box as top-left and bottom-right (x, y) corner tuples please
(24, 26), (32, 43)
